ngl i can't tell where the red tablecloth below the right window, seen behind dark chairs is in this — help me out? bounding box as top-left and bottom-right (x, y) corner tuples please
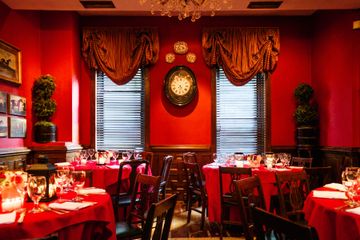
(203, 164), (302, 222)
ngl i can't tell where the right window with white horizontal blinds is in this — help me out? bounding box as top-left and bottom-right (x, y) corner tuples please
(216, 69), (266, 154)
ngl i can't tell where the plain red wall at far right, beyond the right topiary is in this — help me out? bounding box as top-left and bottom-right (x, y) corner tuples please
(312, 12), (360, 147)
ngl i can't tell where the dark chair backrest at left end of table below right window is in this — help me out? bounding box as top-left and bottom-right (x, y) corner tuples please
(184, 162), (206, 197)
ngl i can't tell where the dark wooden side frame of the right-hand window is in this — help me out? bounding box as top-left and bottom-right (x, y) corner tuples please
(211, 67), (271, 152)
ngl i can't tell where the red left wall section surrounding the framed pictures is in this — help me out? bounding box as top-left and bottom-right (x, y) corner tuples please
(0, 2), (41, 148)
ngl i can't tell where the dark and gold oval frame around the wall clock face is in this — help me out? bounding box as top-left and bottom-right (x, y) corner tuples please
(164, 66), (197, 107)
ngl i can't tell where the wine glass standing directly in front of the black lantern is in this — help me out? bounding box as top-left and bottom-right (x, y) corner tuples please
(27, 176), (46, 213)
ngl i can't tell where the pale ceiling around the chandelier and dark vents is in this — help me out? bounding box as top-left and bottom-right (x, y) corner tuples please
(2, 0), (360, 16)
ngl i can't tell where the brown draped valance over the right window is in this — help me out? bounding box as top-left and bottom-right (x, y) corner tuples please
(202, 27), (280, 86)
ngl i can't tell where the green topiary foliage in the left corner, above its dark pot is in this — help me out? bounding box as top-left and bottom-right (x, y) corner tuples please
(32, 75), (56, 125)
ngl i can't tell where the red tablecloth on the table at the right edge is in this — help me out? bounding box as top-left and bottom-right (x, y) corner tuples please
(304, 188), (360, 240)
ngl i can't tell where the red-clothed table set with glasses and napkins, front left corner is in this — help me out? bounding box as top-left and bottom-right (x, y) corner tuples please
(0, 167), (115, 239)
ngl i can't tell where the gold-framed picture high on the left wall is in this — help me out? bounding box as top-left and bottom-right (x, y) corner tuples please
(0, 39), (21, 85)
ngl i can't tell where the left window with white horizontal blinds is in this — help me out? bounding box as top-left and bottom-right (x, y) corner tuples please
(95, 69), (145, 150)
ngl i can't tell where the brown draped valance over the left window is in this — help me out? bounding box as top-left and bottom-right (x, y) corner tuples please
(82, 27), (159, 85)
